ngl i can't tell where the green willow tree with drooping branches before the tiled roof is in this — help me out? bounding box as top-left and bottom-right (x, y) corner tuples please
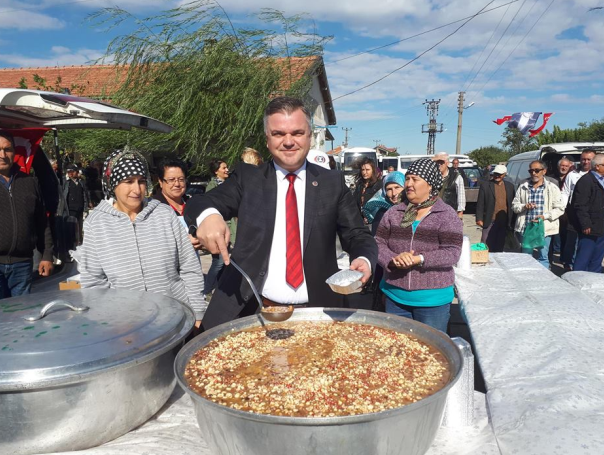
(65, 1), (330, 166)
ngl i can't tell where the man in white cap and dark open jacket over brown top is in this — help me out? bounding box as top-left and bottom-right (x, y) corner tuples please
(476, 164), (514, 253)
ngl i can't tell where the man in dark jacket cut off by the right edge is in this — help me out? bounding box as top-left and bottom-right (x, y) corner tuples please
(569, 154), (604, 273)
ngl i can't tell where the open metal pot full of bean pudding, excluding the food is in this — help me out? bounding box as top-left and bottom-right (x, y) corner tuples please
(175, 308), (462, 455)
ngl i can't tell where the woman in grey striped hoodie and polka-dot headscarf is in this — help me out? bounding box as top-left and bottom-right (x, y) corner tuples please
(74, 150), (207, 325)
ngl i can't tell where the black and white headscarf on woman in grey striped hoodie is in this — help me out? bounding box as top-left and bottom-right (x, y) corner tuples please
(103, 150), (151, 197)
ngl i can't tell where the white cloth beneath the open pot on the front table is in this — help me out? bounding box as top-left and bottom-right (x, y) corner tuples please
(43, 387), (499, 455)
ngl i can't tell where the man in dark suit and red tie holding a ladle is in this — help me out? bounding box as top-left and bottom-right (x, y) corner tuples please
(185, 97), (377, 329)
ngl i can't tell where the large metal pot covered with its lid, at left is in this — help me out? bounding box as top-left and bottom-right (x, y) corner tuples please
(0, 289), (195, 455)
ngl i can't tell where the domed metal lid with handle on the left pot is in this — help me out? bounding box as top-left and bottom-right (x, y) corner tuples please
(0, 289), (195, 392)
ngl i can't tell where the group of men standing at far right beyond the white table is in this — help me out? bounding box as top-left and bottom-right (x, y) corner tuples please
(476, 149), (604, 273)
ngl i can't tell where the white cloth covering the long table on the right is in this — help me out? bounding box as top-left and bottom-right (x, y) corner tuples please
(456, 253), (604, 455)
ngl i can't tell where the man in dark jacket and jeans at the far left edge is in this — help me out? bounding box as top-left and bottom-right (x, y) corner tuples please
(0, 131), (53, 299)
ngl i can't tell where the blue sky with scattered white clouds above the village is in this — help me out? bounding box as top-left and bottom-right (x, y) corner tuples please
(0, 0), (604, 154)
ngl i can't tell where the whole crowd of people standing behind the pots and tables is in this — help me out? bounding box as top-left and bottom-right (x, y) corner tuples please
(0, 97), (604, 332)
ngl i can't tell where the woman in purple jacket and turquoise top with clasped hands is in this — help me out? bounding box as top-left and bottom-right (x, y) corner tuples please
(375, 159), (463, 332)
